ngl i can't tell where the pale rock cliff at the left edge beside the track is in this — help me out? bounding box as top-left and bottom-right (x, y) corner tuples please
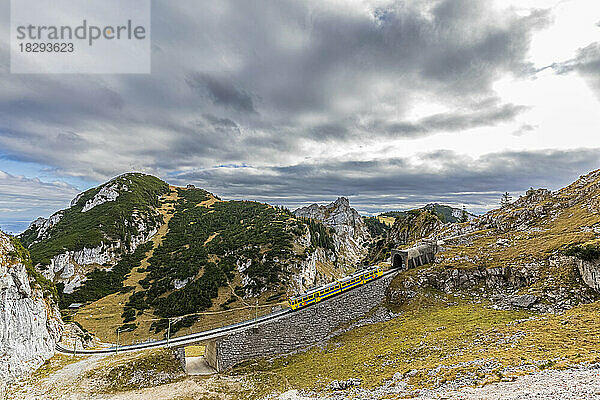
(0, 228), (63, 382)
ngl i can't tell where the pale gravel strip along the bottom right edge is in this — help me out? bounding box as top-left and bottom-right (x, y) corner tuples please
(278, 364), (600, 400)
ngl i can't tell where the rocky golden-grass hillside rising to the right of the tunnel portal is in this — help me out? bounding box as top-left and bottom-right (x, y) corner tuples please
(439, 171), (600, 288)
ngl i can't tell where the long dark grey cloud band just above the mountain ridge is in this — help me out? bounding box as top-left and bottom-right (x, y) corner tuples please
(169, 149), (600, 216)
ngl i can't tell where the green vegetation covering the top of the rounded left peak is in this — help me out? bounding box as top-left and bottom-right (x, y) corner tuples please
(20, 173), (168, 267)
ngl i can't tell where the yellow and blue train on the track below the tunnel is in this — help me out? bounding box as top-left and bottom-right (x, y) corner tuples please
(288, 267), (385, 310)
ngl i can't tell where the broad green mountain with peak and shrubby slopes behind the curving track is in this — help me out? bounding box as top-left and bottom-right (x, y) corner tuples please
(20, 173), (346, 341)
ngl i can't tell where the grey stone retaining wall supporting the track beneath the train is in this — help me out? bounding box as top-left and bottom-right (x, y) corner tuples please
(213, 274), (396, 371)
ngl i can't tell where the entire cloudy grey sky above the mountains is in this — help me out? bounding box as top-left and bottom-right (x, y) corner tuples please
(0, 0), (600, 231)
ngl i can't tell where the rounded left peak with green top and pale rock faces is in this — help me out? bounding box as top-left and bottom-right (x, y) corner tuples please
(19, 173), (169, 293)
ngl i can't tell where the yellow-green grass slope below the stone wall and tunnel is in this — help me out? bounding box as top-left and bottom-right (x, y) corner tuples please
(236, 294), (600, 394)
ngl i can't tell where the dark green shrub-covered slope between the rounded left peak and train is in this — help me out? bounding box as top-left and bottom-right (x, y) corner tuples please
(114, 189), (333, 332)
